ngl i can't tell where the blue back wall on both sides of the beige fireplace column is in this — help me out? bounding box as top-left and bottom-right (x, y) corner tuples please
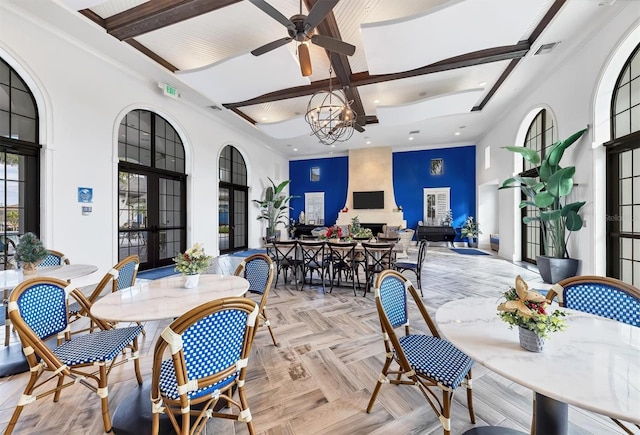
(289, 145), (477, 238)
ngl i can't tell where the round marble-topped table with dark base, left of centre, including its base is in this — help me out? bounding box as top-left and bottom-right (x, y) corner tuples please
(91, 274), (249, 435)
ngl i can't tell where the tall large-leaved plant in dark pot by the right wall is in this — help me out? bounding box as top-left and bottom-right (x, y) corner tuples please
(500, 129), (587, 283)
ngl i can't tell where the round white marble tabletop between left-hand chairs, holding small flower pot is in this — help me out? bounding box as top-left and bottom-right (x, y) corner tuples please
(91, 274), (249, 322)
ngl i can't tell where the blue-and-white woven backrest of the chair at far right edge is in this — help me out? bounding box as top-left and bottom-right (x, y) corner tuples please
(564, 283), (640, 327)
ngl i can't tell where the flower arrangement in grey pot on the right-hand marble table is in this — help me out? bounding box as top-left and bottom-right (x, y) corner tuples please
(498, 275), (567, 352)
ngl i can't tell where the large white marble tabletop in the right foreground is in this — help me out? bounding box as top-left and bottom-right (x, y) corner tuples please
(436, 298), (640, 423)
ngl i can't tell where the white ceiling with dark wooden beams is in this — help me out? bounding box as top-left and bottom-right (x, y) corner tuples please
(12, 0), (627, 158)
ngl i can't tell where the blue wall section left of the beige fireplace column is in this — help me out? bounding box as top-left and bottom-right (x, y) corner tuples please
(289, 156), (349, 226)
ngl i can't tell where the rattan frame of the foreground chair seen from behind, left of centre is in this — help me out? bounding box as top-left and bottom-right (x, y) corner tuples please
(151, 297), (259, 435)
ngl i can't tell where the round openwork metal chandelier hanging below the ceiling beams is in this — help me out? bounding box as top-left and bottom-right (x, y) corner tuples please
(304, 68), (356, 145)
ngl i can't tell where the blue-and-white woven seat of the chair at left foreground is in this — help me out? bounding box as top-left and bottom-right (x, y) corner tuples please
(53, 326), (142, 365)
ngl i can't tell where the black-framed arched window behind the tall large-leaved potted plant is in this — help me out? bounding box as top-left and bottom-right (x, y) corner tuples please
(520, 109), (557, 263)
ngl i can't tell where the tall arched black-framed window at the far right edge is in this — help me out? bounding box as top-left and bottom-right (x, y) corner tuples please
(604, 45), (640, 286)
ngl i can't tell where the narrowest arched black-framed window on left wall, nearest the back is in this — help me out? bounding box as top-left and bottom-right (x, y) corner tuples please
(218, 145), (249, 253)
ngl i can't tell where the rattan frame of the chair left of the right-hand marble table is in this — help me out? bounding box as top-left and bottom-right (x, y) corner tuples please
(367, 270), (475, 435)
